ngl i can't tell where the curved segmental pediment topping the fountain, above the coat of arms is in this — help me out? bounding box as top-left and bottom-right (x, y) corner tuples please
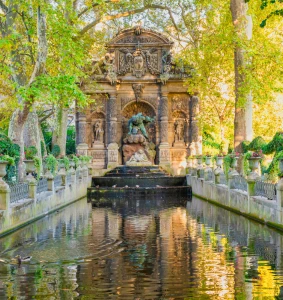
(108, 26), (173, 47)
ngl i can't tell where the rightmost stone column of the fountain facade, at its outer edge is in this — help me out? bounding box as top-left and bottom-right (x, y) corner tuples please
(188, 95), (202, 155)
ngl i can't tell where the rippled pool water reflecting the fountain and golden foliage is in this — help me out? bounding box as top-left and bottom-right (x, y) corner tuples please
(0, 198), (283, 300)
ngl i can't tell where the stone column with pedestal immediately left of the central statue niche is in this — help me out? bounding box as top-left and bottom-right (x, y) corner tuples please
(107, 92), (119, 168)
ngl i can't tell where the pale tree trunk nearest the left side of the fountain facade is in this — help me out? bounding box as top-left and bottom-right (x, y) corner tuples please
(52, 108), (69, 155)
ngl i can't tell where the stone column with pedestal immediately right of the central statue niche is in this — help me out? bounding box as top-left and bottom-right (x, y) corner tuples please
(159, 92), (170, 166)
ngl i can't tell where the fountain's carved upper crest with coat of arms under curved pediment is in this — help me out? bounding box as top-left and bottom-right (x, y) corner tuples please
(87, 26), (192, 85)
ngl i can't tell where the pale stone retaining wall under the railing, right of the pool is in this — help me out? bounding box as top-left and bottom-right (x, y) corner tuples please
(186, 175), (283, 230)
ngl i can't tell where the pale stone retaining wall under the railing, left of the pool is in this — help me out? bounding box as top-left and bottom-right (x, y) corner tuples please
(0, 176), (91, 236)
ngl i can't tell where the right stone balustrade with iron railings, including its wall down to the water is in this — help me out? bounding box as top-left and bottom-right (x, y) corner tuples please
(187, 168), (283, 229)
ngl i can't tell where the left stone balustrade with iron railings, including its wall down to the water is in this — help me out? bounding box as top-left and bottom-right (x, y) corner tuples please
(0, 168), (91, 236)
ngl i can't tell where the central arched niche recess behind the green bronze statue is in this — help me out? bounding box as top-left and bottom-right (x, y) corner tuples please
(122, 101), (156, 144)
